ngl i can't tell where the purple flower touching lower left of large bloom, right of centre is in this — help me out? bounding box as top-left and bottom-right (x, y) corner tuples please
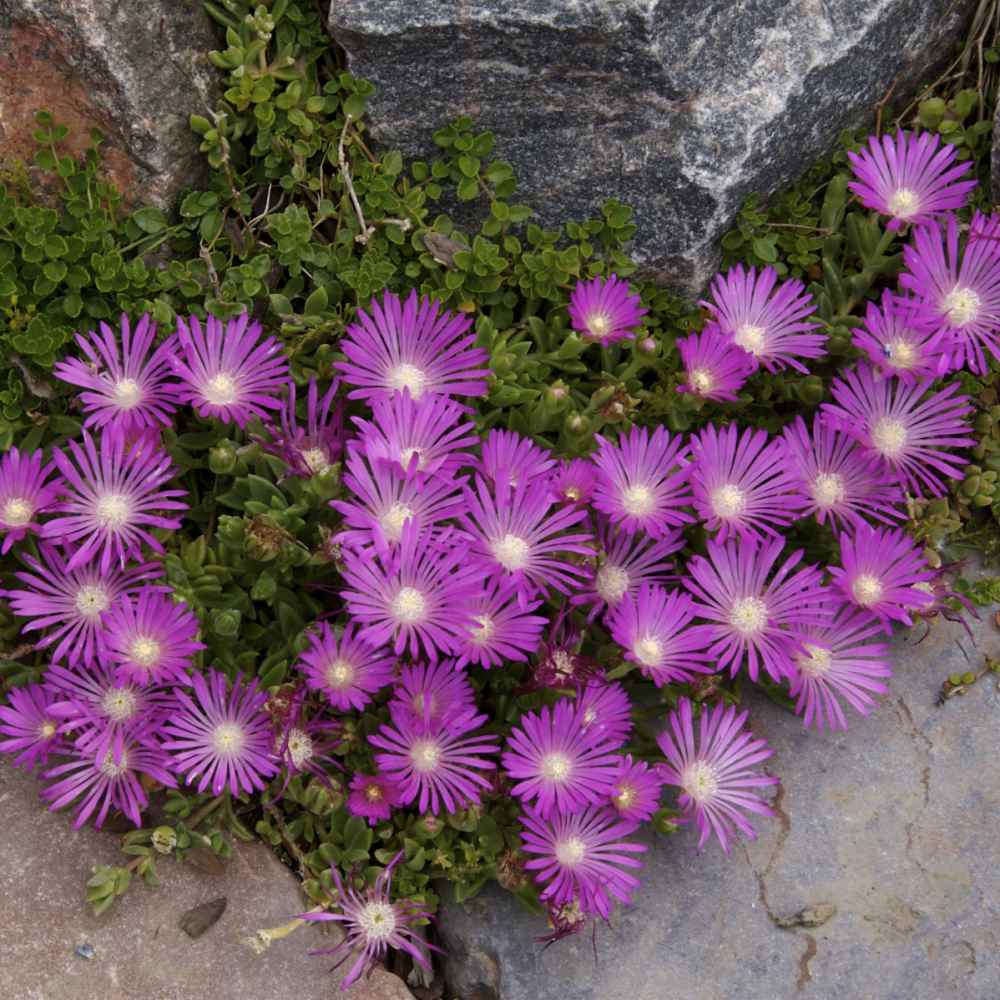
(607, 583), (715, 687)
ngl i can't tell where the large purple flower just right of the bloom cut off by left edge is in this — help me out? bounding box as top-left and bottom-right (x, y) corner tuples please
(40, 431), (187, 573)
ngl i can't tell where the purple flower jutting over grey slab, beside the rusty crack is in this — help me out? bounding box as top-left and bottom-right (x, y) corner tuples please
(656, 698), (778, 854)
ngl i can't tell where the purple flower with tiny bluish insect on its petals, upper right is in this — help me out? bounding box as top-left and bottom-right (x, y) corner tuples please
(852, 289), (950, 382)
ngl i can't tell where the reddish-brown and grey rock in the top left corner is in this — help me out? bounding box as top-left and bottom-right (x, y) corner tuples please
(0, 0), (219, 207)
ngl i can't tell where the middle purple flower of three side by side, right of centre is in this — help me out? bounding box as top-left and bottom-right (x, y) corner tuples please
(691, 424), (806, 542)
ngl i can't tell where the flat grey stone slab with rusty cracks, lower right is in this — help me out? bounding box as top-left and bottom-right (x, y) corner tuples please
(440, 612), (1000, 1000)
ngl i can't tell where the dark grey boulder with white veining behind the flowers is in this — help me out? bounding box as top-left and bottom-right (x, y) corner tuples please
(329, 0), (975, 289)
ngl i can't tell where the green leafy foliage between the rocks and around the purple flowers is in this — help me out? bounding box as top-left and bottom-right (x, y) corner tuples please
(0, 0), (1000, 988)
